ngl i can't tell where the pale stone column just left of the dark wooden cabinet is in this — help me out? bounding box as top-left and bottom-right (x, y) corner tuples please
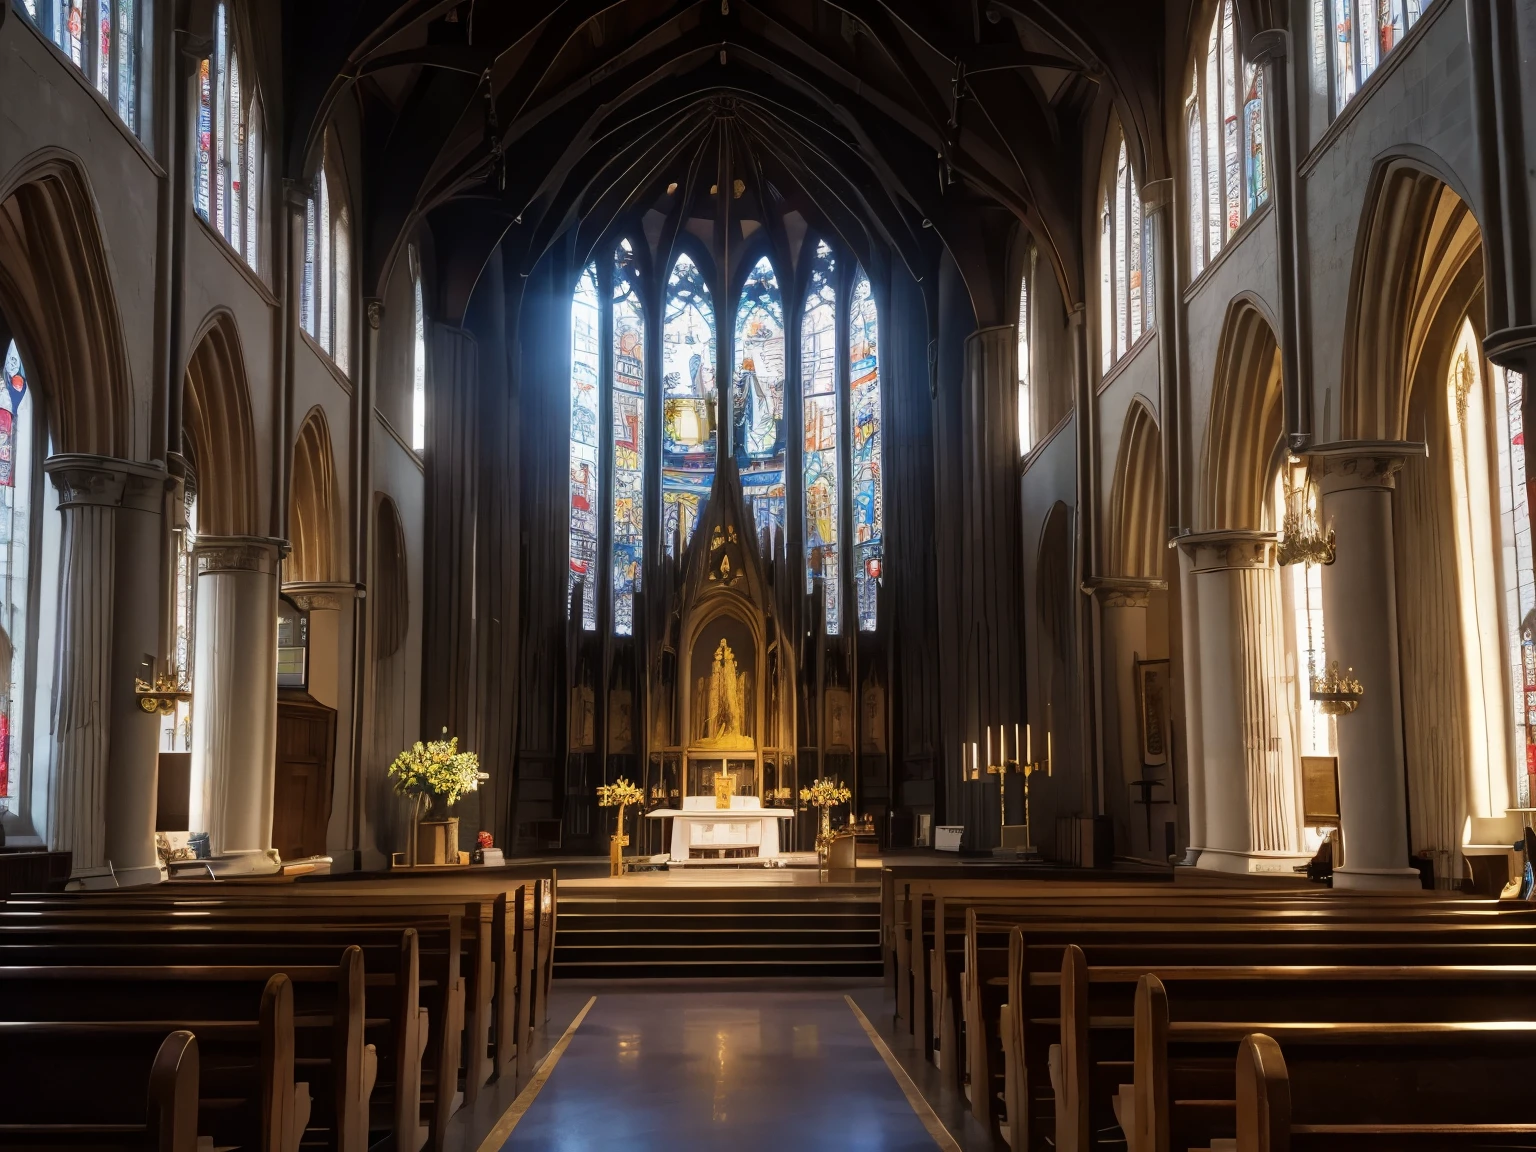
(190, 536), (287, 874)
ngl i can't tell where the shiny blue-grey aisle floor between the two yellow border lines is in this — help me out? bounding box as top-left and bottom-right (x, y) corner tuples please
(502, 989), (954, 1152)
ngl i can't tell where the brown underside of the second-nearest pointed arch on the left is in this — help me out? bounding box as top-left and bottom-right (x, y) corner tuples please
(181, 309), (258, 536)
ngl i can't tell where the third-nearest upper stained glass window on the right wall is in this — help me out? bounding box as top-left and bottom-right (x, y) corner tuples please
(1098, 131), (1152, 372)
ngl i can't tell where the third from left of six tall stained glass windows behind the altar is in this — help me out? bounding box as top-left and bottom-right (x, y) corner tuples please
(662, 252), (717, 554)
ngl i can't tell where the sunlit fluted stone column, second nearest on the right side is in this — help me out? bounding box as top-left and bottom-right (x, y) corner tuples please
(1178, 530), (1307, 872)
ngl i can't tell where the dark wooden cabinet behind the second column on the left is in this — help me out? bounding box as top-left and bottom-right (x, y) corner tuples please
(272, 690), (336, 860)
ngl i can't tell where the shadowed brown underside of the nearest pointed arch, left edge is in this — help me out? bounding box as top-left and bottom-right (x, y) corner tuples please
(0, 149), (134, 458)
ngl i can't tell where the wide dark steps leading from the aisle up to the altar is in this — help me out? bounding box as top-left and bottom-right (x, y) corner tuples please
(554, 886), (882, 980)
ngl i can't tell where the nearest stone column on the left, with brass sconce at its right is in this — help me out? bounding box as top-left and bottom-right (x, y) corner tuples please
(43, 453), (166, 883)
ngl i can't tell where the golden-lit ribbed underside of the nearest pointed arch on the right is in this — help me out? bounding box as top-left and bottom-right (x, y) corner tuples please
(1339, 157), (1482, 439)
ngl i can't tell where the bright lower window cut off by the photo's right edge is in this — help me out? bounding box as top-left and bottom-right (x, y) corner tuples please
(1493, 369), (1536, 808)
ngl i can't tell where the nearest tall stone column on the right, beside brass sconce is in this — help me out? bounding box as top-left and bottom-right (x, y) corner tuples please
(1310, 441), (1424, 888)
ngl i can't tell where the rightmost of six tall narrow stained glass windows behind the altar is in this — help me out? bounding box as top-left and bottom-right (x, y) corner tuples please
(848, 267), (885, 631)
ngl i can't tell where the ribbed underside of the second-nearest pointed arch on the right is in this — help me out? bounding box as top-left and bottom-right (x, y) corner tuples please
(1200, 295), (1284, 530)
